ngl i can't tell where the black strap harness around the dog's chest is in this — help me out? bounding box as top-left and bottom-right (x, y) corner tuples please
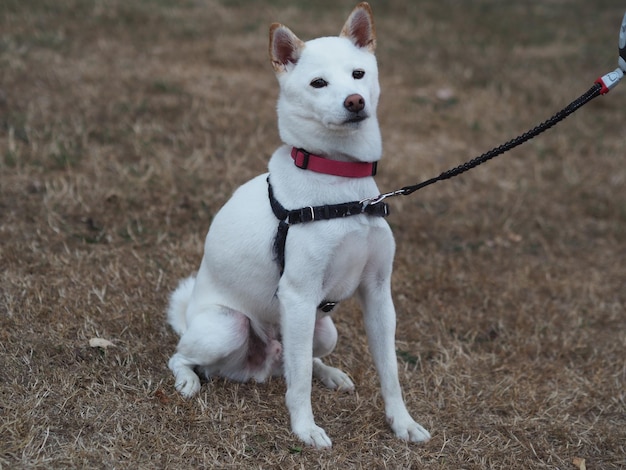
(267, 176), (389, 312)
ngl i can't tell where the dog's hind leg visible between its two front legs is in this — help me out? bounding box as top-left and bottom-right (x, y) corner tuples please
(313, 316), (354, 392)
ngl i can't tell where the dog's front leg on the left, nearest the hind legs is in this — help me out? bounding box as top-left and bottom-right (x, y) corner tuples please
(278, 283), (331, 447)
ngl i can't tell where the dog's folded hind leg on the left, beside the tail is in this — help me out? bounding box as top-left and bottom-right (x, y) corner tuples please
(168, 305), (250, 397)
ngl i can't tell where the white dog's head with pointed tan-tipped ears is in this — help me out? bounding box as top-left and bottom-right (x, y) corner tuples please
(269, 3), (382, 161)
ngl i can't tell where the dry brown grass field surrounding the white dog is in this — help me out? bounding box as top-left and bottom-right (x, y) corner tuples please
(0, 0), (626, 470)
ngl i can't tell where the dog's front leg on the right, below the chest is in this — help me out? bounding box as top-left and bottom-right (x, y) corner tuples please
(359, 275), (430, 442)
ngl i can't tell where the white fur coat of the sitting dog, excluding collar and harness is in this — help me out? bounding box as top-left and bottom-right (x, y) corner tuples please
(168, 3), (430, 447)
